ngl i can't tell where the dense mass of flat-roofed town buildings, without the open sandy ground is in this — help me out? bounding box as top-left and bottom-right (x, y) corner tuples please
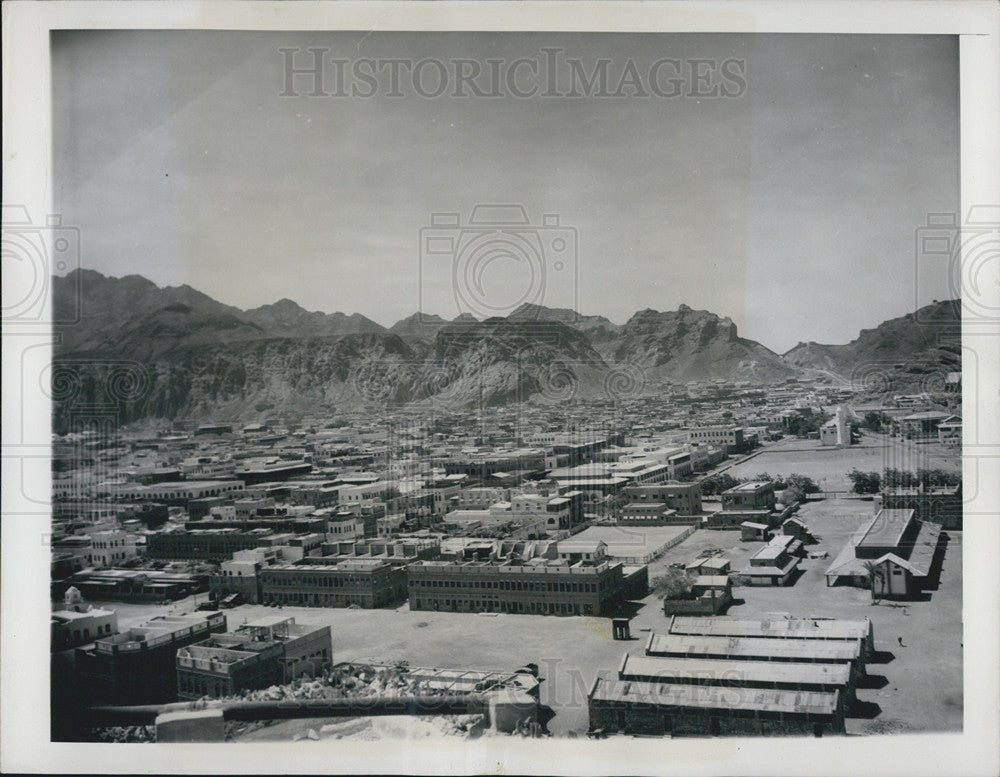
(51, 379), (962, 734)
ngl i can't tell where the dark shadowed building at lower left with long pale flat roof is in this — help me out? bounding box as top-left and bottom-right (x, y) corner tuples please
(76, 612), (226, 704)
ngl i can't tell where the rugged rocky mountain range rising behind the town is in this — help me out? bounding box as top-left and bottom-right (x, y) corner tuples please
(52, 270), (960, 429)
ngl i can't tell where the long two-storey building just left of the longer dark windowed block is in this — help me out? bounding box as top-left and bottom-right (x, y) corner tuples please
(260, 557), (406, 609)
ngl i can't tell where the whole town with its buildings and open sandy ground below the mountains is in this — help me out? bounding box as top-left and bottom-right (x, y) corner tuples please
(51, 373), (962, 741)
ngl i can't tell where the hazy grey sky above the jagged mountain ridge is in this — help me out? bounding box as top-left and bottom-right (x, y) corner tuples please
(52, 31), (959, 353)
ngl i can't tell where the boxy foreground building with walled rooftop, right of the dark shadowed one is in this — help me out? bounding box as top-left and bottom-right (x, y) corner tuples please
(176, 615), (333, 700)
